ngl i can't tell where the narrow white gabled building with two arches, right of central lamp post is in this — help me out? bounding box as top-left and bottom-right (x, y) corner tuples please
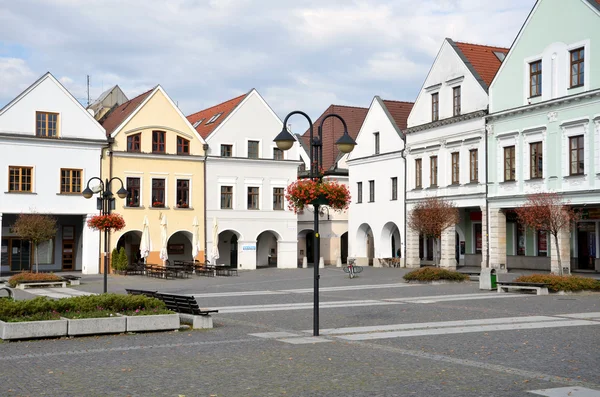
(347, 96), (413, 266)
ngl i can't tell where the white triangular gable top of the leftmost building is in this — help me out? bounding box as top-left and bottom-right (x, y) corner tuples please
(0, 73), (106, 140)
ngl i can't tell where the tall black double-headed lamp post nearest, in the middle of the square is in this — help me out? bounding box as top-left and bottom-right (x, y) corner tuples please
(273, 110), (356, 336)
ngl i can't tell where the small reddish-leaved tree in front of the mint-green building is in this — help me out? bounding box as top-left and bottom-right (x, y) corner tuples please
(516, 192), (578, 275)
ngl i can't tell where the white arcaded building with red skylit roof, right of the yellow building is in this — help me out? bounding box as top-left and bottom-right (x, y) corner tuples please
(188, 89), (301, 269)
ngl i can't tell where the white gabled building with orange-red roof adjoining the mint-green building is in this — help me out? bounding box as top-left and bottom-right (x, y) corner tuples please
(406, 39), (508, 268)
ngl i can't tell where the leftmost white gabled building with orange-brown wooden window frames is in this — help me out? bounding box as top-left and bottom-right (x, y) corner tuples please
(0, 73), (107, 274)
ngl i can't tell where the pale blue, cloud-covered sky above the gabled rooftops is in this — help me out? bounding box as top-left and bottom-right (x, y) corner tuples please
(0, 0), (535, 128)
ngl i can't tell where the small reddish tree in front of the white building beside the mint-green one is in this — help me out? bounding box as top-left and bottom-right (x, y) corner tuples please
(408, 197), (458, 266)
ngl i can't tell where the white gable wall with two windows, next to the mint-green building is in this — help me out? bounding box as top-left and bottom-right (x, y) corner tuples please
(408, 40), (488, 128)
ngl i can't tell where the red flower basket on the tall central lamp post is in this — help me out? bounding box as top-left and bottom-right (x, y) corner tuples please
(285, 178), (350, 213)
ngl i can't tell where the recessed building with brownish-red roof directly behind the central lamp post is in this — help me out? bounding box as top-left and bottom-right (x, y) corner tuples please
(298, 105), (368, 266)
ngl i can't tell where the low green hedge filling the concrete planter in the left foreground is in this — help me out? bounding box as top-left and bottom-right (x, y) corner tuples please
(0, 294), (172, 321)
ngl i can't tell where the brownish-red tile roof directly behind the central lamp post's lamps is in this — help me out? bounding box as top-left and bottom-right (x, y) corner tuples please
(301, 105), (369, 170)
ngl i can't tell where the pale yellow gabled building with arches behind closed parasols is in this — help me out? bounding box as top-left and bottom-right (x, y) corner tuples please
(100, 86), (206, 264)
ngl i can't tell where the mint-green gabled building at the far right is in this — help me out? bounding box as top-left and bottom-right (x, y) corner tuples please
(487, 0), (600, 272)
